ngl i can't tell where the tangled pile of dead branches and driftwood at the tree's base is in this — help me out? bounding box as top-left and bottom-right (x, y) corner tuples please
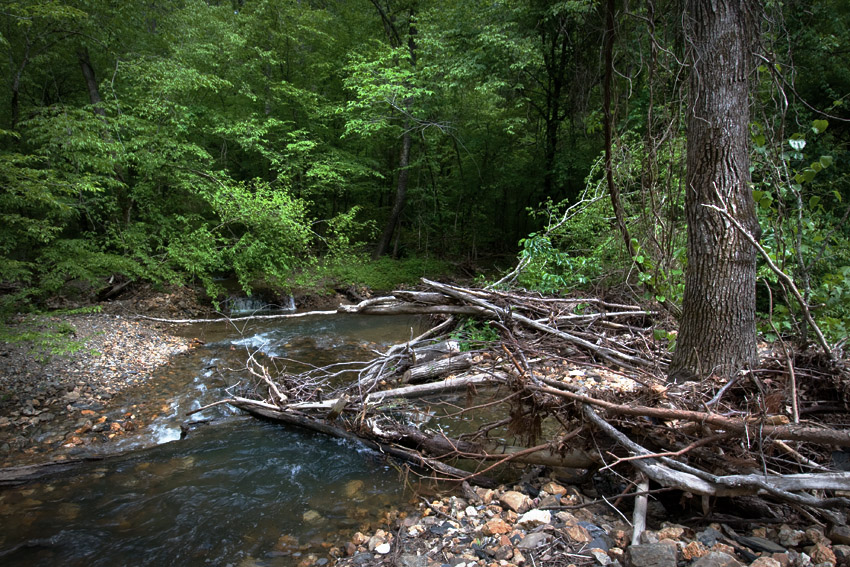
(205, 280), (850, 511)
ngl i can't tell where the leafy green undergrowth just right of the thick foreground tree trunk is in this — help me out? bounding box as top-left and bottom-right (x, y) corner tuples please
(753, 119), (850, 341)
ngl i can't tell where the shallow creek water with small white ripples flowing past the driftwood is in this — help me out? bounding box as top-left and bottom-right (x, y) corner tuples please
(0, 315), (428, 567)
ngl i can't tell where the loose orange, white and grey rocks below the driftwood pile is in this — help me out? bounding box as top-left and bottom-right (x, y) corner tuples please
(332, 478), (850, 567)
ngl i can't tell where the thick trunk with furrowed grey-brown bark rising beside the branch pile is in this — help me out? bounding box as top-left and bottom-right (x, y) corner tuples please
(670, 0), (759, 380)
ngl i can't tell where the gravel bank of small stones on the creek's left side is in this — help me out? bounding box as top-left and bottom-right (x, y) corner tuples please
(0, 302), (193, 467)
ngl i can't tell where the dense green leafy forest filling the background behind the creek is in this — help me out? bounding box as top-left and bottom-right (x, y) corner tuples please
(0, 0), (850, 360)
